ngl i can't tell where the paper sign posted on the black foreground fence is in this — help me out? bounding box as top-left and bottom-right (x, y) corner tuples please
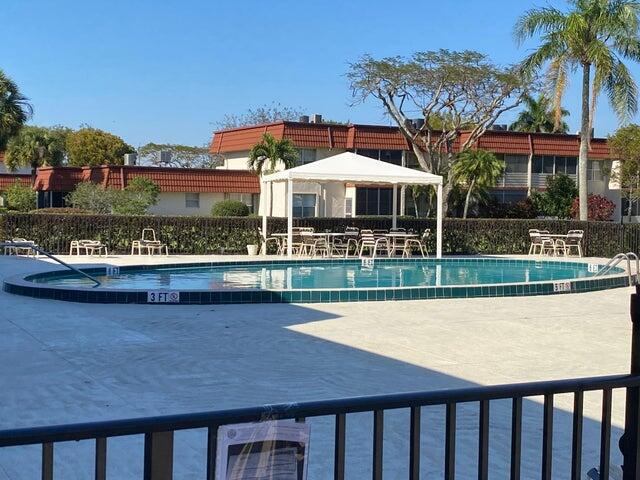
(216, 420), (310, 480)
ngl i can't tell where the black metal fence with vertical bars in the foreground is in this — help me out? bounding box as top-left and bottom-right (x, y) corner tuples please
(0, 291), (640, 480)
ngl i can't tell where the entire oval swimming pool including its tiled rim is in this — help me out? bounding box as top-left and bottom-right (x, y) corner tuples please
(3, 258), (628, 304)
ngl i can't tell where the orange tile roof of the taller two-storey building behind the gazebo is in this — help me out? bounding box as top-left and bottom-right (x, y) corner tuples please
(211, 121), (610, 158)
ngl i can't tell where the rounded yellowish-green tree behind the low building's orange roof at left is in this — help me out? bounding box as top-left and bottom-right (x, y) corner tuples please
(67, 127), (135, 167)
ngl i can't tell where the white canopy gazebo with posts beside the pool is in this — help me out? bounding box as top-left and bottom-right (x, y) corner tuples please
(261, 152), (442, 258)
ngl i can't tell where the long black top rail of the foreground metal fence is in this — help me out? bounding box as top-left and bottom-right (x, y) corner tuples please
(0, 374), (640, 447)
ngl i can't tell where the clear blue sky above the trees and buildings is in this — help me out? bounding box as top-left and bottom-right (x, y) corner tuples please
(0, 0), (640, 146)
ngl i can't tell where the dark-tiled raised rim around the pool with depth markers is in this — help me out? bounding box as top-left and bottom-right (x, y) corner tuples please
(3, 256), (637, 305)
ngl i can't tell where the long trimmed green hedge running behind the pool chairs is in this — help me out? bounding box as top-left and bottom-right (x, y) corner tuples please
(0, 213), (640, 257)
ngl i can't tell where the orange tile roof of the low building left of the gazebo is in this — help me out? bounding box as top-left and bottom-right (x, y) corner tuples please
(35, 165), (260, 193)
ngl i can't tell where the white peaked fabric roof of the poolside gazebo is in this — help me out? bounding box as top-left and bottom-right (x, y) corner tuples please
(262, 152), (442, 185)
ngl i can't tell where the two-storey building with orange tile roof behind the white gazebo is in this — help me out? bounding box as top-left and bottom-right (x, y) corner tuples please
(210, 117), (623, 219)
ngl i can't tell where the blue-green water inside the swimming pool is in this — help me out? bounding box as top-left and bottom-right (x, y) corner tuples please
(30, 259), (604, 291)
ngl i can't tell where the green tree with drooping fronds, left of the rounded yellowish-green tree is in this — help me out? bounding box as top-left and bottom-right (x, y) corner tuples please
(5, 126), (70, 183)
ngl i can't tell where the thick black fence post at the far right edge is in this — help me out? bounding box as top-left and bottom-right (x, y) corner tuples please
(620, 286), (640, 480)
